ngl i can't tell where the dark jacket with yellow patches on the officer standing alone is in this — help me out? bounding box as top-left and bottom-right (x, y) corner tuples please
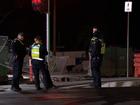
(89, 37), (105, 57)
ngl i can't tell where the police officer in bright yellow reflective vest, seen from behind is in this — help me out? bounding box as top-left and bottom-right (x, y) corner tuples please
(29, 36), (54, 90)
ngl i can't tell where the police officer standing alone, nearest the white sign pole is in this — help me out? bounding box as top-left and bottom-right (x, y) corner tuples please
(89, 27), (105, 88)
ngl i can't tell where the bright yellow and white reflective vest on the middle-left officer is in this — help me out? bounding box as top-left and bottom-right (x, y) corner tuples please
(31, 44), (43, 60)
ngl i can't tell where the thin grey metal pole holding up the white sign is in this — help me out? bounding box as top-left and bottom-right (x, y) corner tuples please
(127, 12), (129, 77)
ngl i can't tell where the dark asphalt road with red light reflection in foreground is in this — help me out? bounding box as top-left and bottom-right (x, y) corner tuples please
(0, 85), (140, 105)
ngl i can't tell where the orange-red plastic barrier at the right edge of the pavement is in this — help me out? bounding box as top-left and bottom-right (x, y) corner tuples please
(134, 53), (140, 77)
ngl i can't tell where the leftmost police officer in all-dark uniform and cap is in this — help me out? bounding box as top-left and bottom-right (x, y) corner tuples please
(11, 33), (26, 91)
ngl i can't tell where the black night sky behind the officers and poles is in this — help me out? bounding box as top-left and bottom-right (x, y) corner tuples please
(0, 0), (140, 50)
